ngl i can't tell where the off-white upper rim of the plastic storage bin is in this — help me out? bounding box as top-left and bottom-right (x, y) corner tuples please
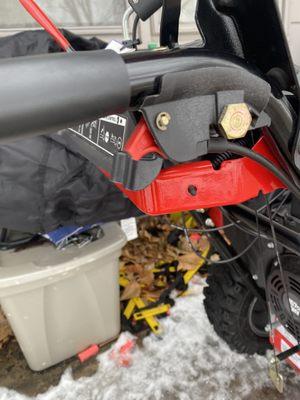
(0, 222), (126, 298)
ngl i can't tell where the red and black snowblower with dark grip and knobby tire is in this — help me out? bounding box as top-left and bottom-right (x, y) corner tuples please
(0, 0), (300, 391)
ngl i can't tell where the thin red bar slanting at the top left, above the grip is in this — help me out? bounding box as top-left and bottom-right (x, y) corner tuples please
(19, 0), (73, 51)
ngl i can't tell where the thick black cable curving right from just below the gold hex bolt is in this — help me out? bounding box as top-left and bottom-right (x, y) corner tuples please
(208, 139), (300, 199)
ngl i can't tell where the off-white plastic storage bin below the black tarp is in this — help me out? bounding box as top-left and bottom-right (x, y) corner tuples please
(0, 223), (126, 371)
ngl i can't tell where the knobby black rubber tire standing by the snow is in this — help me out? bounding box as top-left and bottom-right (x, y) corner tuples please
(204, 265), (271, 355)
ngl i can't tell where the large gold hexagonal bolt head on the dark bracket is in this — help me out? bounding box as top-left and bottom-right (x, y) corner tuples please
(219, 103), (252, 140)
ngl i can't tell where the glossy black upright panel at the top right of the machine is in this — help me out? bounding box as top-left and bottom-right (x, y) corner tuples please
(196, 0), (300, 171)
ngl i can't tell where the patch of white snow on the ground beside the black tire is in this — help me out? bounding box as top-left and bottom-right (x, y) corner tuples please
(0, 285), (300, 400)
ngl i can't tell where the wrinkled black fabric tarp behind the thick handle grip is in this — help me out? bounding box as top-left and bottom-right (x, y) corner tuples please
(0, 31), (139, 233)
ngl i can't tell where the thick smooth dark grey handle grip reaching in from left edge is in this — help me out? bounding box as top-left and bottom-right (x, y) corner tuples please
(0, 50), (131, 142)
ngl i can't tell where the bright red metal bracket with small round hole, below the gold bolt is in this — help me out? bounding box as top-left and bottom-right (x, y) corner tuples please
(110, 120), (285, 215)
